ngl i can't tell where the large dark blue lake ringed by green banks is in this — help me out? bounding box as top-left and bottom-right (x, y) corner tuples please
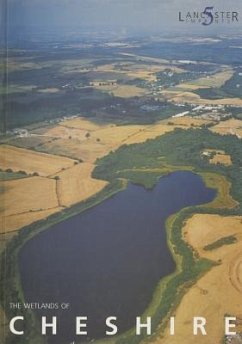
(19, 172), (215, 344)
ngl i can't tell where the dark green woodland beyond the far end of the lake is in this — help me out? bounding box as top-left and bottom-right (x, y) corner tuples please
(93, 128), (242, 208)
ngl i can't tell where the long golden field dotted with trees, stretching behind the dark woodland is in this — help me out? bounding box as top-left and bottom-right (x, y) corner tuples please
(7, 116), (216, 164)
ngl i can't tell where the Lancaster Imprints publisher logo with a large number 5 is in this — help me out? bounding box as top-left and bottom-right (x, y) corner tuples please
(178, 6), (239, 26)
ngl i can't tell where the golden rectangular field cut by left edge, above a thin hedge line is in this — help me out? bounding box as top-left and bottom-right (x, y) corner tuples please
(0, 177), (58, 216)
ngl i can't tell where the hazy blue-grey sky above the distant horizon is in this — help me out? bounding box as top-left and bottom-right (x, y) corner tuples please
(7, 0), (242, 35)
